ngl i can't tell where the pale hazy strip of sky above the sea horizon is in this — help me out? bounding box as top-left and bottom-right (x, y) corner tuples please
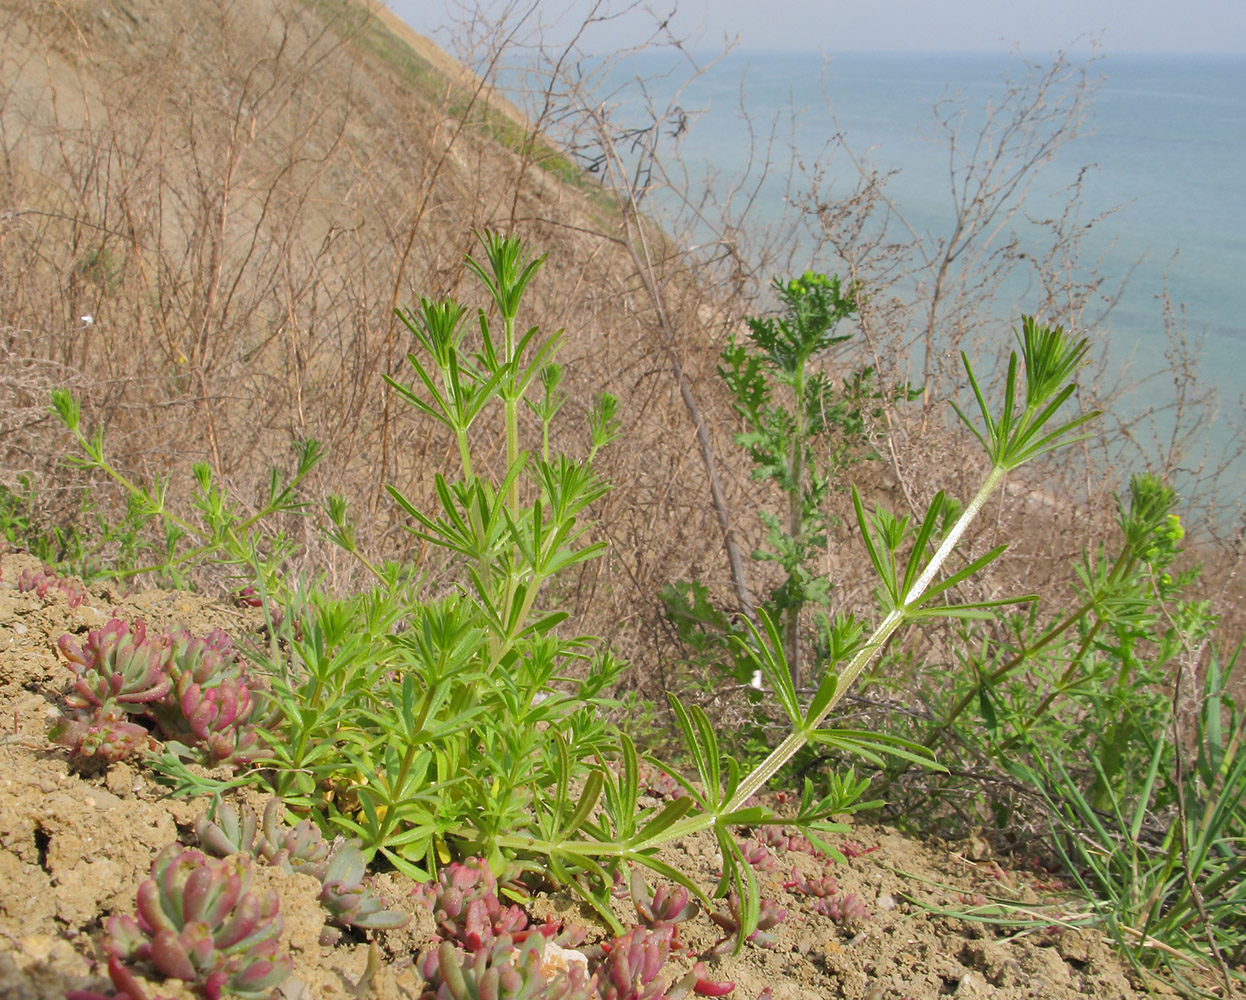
(385, 0), (1246, 55)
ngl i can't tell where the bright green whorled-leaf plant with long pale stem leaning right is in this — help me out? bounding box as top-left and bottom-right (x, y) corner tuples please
(56, 235), (1116, 951)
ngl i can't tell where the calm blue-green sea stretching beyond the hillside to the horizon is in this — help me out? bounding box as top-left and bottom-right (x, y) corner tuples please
(528, 51), (1246, 508)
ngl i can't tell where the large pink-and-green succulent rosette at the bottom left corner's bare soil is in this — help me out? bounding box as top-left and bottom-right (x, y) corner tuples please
(107, 844), (292, 1000)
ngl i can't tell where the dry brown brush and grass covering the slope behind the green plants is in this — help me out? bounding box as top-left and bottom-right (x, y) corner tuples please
(0, 0), (1240, 712)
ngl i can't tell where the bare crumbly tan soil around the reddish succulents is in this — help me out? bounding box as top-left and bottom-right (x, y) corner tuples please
(0, 554), (1171, 1000)
